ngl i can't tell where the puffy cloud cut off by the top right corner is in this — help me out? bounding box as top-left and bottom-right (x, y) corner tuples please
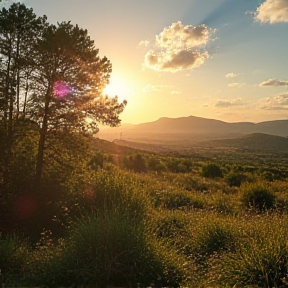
(254, 0), (288, 24)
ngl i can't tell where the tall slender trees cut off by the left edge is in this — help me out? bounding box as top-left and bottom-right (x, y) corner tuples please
(0, 3), (46, 194)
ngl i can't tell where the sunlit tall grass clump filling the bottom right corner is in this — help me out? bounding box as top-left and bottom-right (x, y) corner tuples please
(209, 215), (288, 287)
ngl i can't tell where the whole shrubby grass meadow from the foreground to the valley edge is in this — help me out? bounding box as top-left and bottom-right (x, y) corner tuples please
(0, 135), (288, 287)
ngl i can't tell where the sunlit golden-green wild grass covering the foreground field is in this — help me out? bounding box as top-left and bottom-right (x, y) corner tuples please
(0, 152), (288, 288)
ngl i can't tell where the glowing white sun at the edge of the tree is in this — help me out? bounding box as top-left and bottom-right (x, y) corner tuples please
(103, 78), (131, 101)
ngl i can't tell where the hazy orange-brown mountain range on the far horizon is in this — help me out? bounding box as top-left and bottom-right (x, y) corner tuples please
(99, 116), (288, 142)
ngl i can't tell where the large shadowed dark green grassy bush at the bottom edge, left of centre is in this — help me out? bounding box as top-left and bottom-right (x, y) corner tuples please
(36, 212), (187, 288)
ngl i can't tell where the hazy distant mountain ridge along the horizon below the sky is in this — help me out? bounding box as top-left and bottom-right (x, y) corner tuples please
(99, 116), (288, 137)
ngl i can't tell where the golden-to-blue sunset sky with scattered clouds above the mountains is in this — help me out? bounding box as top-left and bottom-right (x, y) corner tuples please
(0, 0), (288, 124)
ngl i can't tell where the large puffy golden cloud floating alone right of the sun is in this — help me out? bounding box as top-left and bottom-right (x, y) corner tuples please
(144, 21), (213, 72)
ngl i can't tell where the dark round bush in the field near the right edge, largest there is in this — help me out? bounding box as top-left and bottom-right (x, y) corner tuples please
(241, 183), (276, 211)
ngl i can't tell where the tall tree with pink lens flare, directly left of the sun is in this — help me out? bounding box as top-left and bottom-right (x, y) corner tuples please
(29, 22), (126, 183)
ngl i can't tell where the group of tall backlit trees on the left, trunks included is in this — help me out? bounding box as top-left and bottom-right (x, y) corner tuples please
(0, 3), (126, 190)
